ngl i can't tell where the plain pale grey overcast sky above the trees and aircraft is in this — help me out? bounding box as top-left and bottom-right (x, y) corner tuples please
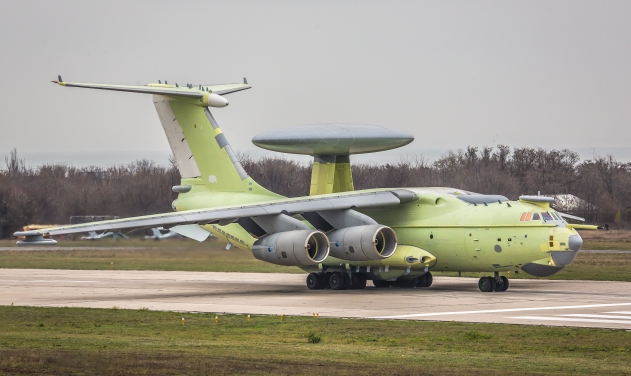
(0, 0), (631, 163)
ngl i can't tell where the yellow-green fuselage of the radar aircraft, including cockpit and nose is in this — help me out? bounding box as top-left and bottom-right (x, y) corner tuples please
(174, 187), (582, 278)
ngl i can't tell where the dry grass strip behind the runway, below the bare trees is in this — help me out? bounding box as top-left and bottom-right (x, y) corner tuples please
(0, 236), (631, 281)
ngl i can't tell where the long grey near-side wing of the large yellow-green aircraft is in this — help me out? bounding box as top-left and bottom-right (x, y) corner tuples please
(14, 189), (418, 242)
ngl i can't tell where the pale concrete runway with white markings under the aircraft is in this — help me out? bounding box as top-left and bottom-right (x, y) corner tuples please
(0, 269), (631, 329)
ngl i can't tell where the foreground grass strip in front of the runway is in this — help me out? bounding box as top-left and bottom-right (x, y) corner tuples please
(0, 307), (631, 375)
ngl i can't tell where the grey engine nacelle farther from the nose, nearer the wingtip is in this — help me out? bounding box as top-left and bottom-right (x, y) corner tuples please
(252, 230), (329, 266)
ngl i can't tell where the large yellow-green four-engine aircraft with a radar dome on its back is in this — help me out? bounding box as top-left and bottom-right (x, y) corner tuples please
(15, 77), (596, 292)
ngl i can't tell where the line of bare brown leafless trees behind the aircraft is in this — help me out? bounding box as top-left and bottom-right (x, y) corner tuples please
(0, 145), (631, 237)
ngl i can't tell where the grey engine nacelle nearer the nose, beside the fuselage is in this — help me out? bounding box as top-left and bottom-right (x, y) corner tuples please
(327, 225), (397, 261)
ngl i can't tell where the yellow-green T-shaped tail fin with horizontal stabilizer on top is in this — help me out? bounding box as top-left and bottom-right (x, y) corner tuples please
(53, 77), (274, 195)
